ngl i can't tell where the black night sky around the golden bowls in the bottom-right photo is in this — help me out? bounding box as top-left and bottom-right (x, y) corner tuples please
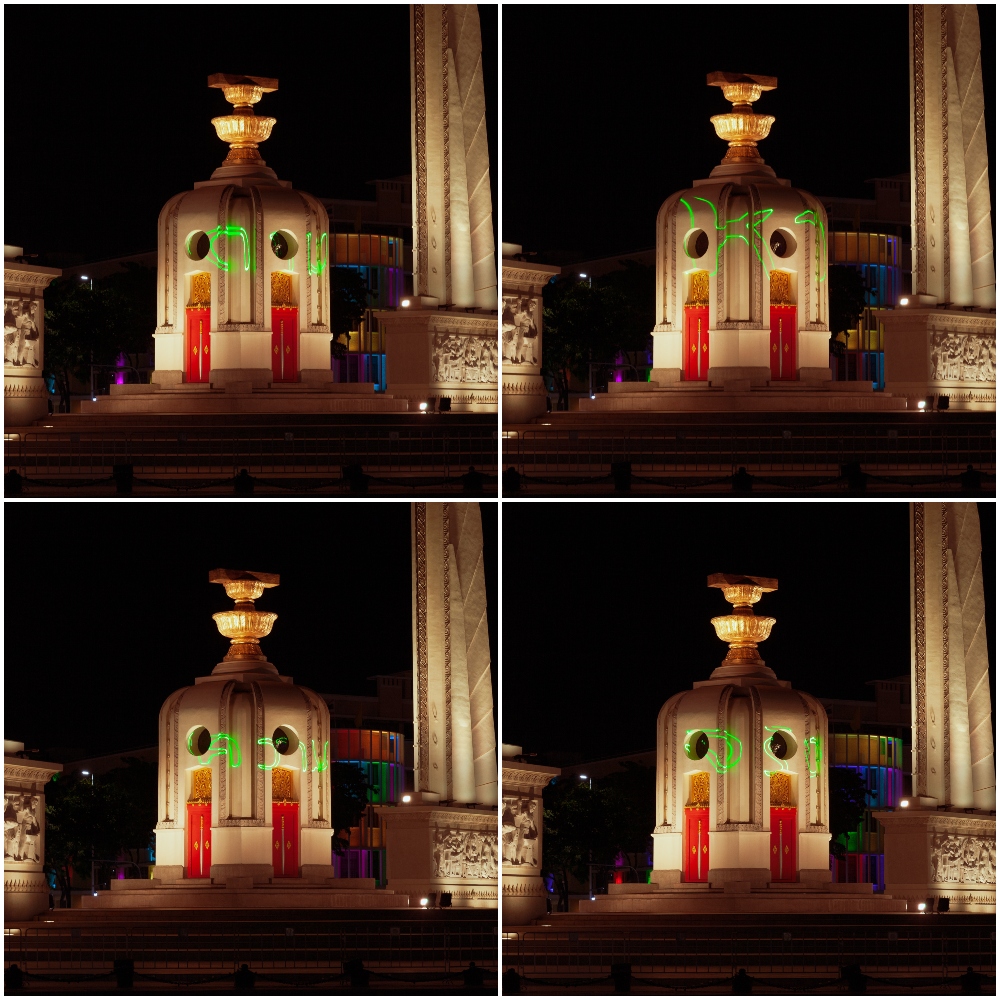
(502, 501), (996, 759)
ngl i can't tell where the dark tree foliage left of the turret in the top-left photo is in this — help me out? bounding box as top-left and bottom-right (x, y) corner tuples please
(43, 263), (156, 413)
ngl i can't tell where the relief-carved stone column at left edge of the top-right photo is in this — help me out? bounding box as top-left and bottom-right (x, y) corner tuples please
(500, 252), (560, 424)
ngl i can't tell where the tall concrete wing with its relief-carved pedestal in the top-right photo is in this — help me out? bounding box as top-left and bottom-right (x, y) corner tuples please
(885, 4), (996, 410)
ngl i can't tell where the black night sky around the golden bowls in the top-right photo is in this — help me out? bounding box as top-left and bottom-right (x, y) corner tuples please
(502, 4), (996, 260)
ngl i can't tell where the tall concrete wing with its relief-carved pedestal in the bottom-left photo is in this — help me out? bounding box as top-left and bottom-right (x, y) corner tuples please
(376, 503), (498, 907)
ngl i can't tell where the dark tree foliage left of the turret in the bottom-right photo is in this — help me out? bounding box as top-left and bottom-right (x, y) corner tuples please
(542, 762), (656, 912)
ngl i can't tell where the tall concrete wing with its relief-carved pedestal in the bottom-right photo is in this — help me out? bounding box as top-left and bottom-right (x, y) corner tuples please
(879, 503), (996, 912)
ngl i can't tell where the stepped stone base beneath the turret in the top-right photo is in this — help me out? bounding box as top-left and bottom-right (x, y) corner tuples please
(576, 368), (907, 413)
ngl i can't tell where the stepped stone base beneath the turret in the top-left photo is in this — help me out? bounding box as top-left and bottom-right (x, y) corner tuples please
(75, 380), (408, 415)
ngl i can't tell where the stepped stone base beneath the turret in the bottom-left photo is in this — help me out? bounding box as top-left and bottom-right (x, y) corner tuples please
(77, 866), (410, 911)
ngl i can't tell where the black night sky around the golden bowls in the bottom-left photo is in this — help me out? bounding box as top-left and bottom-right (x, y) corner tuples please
(4, 501), (497, 760)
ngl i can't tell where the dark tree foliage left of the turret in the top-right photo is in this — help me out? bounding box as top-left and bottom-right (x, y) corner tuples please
(542, 261), (655, 410)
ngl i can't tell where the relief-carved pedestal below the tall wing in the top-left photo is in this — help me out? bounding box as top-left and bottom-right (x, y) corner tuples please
(376, 306), (500, 413)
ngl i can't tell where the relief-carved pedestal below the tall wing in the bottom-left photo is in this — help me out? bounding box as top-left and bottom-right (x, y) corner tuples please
(376, 804), (499, 909)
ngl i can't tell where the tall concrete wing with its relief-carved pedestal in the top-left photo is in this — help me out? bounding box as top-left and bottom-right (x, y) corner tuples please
(378, 4), (499, 412)
